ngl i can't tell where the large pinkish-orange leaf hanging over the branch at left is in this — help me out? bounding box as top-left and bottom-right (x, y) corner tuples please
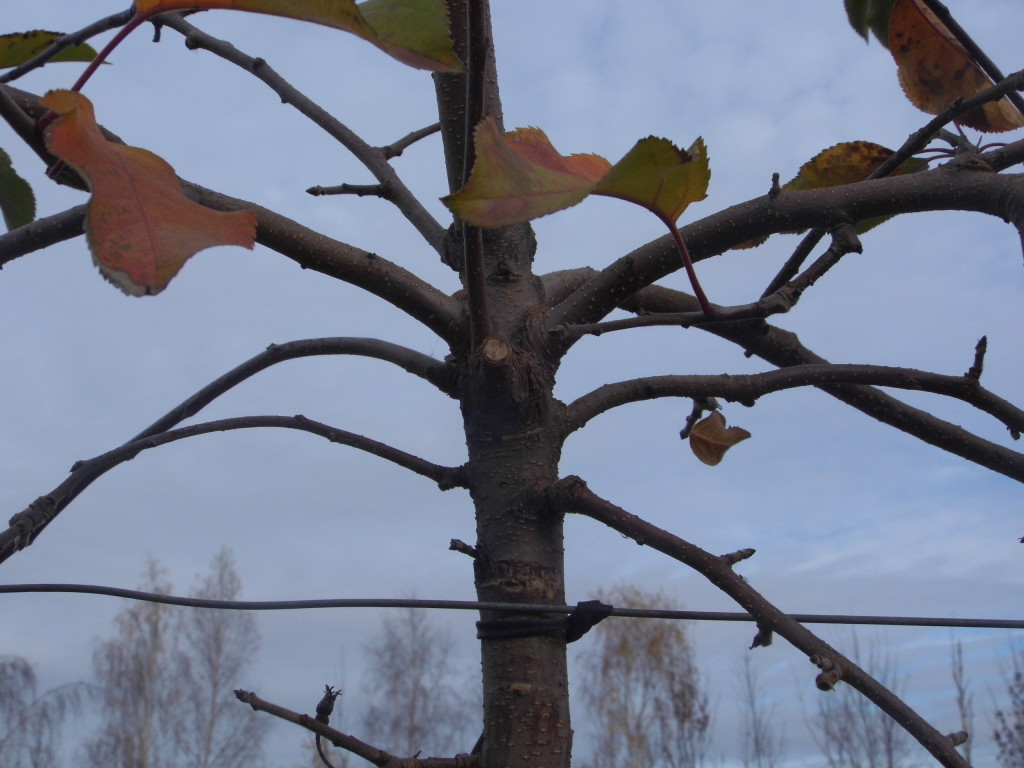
(40, 91), (256, 296)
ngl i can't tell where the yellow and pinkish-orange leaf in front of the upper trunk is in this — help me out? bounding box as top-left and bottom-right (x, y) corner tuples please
(442, 118), (611, 227)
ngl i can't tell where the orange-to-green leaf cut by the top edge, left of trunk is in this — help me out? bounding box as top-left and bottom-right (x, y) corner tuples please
(135, 0), (462, 72)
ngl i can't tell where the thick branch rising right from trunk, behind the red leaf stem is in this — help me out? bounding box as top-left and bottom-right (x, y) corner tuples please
(546, 72), (1024, 330)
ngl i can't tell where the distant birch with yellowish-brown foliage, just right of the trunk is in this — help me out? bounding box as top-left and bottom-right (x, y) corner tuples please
(579, 587), (711, 768)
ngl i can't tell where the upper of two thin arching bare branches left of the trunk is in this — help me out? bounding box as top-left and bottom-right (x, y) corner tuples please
(130, 336), (456, 441)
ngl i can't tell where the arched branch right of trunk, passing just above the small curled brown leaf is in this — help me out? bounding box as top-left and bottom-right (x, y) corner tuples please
(566, 362), (1024, 438)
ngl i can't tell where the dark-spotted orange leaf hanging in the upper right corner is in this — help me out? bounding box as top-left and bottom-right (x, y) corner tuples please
(889, 0), (1024, 133)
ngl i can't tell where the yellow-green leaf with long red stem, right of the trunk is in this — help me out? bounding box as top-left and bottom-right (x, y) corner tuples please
(594, 136), (711, 226)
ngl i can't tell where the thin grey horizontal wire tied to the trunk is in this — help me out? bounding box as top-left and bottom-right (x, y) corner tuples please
(0, 584), (1024, 630)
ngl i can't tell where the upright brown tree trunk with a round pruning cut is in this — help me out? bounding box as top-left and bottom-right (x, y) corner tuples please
(435, 0), (572, 768)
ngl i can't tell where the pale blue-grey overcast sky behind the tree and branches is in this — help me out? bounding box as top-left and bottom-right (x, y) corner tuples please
(0, 0), (1024, 762)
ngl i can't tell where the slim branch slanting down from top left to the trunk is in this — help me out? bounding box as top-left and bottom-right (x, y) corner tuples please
(156, 13), (444, 256)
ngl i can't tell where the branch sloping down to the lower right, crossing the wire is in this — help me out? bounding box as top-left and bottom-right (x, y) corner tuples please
(548, 477), (969, 768)
